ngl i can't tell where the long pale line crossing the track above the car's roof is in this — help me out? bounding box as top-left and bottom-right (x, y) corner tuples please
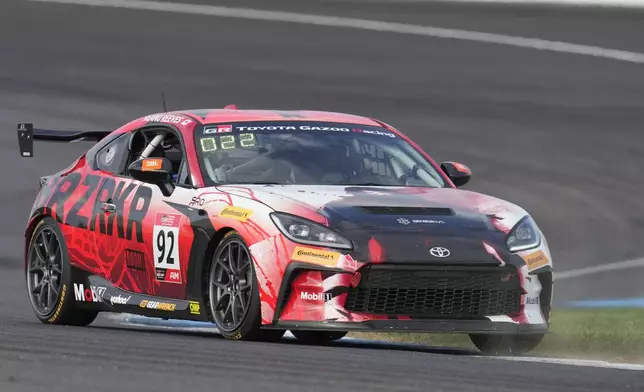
(31, 0), (644, 64)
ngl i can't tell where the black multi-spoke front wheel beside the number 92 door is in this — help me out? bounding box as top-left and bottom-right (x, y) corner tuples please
(208, 231), (286, 341)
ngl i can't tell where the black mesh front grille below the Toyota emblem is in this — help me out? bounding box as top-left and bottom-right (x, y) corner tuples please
(345, 265), (522, 318)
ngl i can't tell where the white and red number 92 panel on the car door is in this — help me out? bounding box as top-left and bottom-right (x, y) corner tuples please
(152, 212), (182, 283)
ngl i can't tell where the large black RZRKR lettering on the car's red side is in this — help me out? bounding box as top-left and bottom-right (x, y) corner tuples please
(45, 173), (152, 243)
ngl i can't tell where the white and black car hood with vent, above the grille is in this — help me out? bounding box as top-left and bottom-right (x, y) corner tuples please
(219, 185), (527, 263)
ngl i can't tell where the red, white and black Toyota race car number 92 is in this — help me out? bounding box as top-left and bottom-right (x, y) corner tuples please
(18, 107), (553, 353)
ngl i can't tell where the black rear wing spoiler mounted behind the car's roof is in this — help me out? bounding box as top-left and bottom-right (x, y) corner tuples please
(18, 123), (112, 158)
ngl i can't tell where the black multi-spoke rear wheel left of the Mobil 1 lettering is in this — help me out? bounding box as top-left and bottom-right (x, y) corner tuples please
(26, 217), (98, 326)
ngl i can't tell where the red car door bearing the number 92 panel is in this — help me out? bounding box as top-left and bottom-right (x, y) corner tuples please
(96, 127), (194, 299)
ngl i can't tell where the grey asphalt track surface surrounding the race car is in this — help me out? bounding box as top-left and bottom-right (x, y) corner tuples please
(0, 0), (644, 392)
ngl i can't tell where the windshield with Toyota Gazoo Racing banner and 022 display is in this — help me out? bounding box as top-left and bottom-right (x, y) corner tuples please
(195, 121), (445, 188)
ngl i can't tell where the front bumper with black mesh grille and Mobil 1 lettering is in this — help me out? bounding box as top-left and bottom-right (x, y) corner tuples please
(270, 263), (552, 334)
